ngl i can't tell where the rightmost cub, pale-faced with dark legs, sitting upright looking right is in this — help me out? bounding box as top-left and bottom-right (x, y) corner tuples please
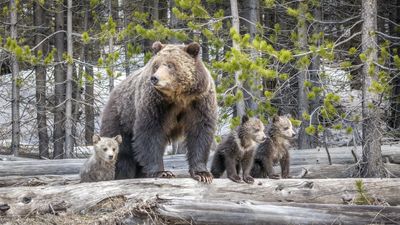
(251, 116), (295, 178)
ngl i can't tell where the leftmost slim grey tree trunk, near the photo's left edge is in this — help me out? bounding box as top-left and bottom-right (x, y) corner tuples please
(10, 0), (21, 156)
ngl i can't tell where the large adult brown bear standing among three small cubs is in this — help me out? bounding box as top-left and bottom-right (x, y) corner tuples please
(100, 42), (217, 183)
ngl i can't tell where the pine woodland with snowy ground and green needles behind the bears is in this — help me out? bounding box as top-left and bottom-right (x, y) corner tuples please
(0, 0), (400, 177)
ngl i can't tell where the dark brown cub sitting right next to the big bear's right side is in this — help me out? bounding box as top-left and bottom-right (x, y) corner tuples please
(211, 116), (266, 183)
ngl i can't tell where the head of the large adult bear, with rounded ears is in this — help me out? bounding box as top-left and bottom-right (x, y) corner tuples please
(150, 42), (200, 96)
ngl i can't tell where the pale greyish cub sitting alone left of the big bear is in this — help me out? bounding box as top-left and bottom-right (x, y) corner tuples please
(80, 134), (122, 182)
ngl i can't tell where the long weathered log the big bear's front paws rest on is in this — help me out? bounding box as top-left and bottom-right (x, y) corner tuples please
(0, 178), (400, 216)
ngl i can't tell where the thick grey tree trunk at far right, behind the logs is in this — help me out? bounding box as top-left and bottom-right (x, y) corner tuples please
(361, 0), (386, 177)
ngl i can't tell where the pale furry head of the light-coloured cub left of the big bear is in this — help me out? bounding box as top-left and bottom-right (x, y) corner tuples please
(93, 134), (122, 162)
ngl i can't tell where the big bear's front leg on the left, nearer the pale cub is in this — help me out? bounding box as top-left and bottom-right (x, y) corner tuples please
(132, 118), (175, 178)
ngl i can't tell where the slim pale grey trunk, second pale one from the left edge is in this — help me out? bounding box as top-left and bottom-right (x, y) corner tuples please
(65, 0), (74, 158)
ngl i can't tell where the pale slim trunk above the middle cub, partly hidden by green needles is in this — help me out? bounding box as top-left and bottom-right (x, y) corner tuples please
(230, 0), (246, 117)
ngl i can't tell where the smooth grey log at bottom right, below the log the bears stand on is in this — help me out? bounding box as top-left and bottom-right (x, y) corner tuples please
(153, 199), (400, 225)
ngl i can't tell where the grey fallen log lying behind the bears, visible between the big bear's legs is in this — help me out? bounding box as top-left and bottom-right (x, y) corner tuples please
(0, 160), (400, 184)
